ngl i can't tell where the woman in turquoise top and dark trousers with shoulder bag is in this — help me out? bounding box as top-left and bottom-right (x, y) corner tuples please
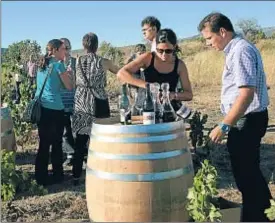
(35, 39), (72, 185)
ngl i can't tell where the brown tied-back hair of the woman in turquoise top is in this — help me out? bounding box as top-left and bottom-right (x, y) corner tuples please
(38, 39), (64, 70)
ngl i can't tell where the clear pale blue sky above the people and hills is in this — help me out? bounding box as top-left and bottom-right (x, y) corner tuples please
(1, 1), (275, 49)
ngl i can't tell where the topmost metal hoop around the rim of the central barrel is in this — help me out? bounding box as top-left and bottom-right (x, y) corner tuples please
(92, 117), (185, 134)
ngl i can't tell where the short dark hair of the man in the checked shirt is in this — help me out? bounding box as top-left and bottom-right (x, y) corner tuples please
(198, 12), (234, 33)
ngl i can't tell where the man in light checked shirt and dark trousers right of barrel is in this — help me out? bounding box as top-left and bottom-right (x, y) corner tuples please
(198, 13), (272, 222)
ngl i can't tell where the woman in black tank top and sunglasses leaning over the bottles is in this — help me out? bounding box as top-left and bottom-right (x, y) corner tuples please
(118, 29), (193, 110)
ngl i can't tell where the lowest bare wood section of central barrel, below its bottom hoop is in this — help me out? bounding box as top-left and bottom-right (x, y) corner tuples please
(86, 176), (193, 222)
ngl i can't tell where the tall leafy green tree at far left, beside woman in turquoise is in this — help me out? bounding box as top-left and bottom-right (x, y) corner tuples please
(1, 40), (41, 149)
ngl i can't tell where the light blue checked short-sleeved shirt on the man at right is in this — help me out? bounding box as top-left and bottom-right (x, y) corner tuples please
(221, 36), (269, 115)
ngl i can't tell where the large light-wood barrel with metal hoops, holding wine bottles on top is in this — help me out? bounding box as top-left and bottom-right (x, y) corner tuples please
(86, 118), (194, 222)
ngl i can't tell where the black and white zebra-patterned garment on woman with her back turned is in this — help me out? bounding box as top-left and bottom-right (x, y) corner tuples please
(72, 53), (108, 135)
